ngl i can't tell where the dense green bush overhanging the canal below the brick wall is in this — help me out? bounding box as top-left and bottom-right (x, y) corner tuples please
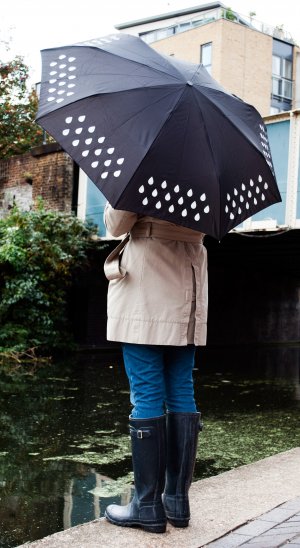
(0, 202), (99, 353)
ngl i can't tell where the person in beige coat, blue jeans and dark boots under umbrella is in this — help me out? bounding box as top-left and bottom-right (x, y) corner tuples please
(104, 204), (208, 533)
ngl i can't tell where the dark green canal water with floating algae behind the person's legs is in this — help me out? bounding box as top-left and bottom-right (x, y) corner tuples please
(0, 346), (300, 548)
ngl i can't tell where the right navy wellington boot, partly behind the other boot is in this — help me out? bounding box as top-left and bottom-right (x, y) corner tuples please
(163, 412), (202, 527)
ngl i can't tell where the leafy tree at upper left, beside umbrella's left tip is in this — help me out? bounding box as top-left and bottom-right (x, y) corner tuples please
(0, 56), (43, 159)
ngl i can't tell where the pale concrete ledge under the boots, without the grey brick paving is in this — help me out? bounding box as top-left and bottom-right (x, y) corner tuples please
(22, 447), (300, 548)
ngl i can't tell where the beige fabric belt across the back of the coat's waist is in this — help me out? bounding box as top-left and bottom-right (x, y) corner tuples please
(130, 222), (204, 244)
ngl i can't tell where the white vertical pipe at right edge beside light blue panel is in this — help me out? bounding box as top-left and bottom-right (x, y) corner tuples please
(285, 109), (300, 227)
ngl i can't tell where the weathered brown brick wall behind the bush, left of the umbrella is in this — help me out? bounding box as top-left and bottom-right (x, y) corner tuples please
(0, 143), (74, 217)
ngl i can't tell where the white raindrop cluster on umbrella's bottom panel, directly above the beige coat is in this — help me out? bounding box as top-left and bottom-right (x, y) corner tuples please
(139, 177), (210, 221)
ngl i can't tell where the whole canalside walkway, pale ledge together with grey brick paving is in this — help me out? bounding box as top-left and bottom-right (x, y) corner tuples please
(19, 447), (300, 548)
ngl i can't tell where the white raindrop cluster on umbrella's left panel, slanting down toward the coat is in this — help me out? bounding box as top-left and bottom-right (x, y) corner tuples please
(62, 114), (125, 179)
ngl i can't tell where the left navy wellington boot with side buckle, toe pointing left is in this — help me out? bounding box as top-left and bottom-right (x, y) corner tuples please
(105, 415), (167, 533)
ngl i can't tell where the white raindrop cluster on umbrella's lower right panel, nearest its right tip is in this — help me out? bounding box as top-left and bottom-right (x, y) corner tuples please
(225, 175), (269, 221)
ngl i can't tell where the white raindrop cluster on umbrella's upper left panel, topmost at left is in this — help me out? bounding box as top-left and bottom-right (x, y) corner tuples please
(47, 53), (77, 104)
